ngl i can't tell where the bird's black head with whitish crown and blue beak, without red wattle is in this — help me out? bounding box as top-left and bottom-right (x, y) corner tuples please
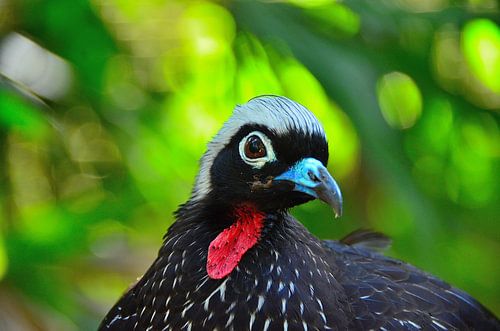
(192, 96), (342, 216)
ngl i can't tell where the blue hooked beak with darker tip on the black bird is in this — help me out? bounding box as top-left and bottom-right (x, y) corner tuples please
(274, 158), (342, 217)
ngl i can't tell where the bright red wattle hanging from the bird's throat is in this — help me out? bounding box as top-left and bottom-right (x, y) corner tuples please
(207, 205), (264, 279)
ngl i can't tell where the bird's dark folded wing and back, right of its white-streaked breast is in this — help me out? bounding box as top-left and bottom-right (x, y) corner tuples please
(323, 233), (500, 330)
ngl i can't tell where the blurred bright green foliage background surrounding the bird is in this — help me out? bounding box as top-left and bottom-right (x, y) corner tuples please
(0, 0), (500, 330)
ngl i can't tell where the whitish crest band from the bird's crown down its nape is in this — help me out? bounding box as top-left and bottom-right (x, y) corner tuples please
(191, 96), (325, 200)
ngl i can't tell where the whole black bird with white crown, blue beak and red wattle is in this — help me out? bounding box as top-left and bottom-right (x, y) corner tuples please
(99, 95), (500, 331)
